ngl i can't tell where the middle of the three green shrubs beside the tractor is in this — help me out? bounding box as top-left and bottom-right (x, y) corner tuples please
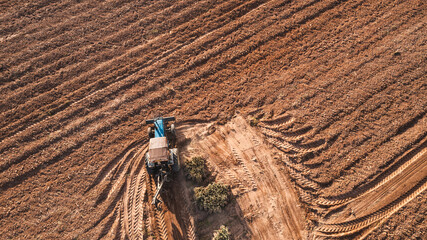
(194, 183), (230, 213)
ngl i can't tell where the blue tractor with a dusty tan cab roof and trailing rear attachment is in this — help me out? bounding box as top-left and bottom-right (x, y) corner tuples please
(145, 117), (180, 205)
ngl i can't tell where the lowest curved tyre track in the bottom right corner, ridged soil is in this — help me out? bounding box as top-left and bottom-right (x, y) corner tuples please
(316, 178), (427, 236)
